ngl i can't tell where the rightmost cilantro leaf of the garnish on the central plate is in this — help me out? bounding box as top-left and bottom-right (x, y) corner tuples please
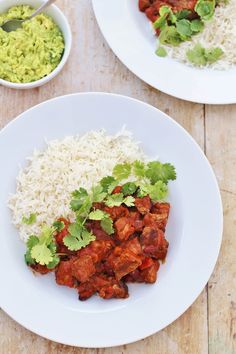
(146, 161), (176, 184)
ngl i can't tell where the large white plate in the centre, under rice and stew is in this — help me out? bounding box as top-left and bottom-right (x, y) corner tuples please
(0, 93), (222, 347)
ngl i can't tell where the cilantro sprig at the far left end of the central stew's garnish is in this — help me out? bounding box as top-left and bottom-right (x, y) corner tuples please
(25, 225), (59, 267)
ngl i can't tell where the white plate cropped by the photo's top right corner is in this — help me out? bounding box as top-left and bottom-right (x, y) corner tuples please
(92, 0), (236, 104)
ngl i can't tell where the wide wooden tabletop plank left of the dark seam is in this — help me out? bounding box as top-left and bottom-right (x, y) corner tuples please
(0, 0), (208, 354)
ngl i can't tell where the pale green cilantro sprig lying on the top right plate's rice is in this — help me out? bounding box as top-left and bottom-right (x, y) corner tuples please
(186, 43), (224, 66)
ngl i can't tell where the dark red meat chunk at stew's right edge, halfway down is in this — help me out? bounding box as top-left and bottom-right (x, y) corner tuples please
(140, 226), (169, 260)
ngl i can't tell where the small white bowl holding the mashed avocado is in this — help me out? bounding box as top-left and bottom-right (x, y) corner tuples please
(0, 0), (72, 89)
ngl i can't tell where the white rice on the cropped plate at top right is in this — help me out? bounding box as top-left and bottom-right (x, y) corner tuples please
(165, 0), (236, 70)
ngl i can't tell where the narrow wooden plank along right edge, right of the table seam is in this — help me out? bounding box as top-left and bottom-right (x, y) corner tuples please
(206, 105), (236, 354)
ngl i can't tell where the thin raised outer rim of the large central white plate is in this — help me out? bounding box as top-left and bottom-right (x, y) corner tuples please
(0, 91), (223, 348)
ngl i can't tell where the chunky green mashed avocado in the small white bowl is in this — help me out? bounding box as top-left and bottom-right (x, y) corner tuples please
(0, 5), (65, 83)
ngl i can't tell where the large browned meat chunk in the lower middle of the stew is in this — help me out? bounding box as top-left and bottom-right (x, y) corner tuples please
(107, 247), (142, 280)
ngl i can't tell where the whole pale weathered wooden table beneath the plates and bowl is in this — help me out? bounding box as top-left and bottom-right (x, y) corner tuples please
(0, 0), (236, 354)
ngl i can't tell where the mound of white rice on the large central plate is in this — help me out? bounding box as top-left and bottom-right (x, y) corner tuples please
(8, 129), (145, 242)
